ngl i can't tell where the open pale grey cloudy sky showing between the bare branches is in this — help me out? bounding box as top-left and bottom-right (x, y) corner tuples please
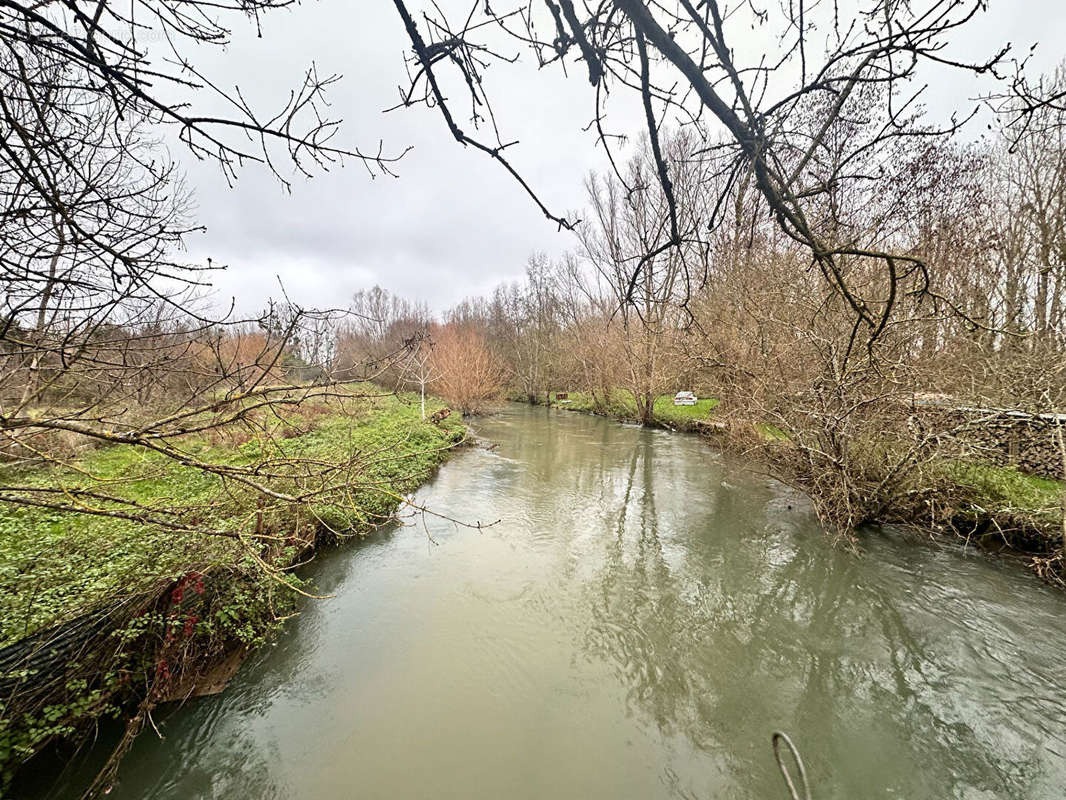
(164, 0), (1066, 320)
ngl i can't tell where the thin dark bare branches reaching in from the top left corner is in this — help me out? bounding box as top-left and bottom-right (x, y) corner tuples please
(0, 0), (402, 192)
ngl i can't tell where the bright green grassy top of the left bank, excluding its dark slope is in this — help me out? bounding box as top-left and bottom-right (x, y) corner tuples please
(0, 386), (463, 646)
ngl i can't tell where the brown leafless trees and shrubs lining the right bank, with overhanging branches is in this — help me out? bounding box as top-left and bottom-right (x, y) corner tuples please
(368, 0), (1066, 577)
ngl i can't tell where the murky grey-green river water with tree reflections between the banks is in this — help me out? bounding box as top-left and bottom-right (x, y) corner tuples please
(33, 406), (1066, 800)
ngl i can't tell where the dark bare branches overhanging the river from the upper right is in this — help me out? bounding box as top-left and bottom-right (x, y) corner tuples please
(393, 0), (1062, 340)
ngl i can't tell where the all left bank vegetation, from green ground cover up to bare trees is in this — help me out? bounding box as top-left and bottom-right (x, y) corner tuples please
(0, 0), (492, 796)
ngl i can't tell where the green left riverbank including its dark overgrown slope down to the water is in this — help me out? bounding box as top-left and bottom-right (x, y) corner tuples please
(0, 388), (465, 785)
